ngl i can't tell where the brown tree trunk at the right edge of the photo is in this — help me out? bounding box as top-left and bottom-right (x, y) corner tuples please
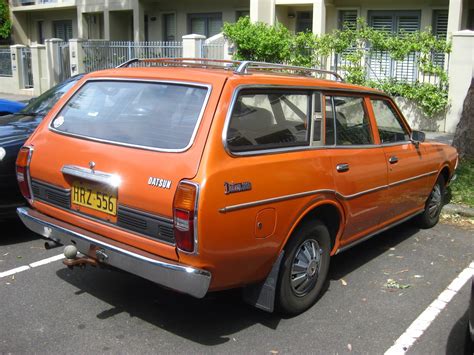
(453, 78), (474, 159)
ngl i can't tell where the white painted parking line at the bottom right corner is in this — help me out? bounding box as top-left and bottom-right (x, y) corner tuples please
(385, 262), (474, 355)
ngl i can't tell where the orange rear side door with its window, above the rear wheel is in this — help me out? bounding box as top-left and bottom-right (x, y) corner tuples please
(325, 94), (387, 245)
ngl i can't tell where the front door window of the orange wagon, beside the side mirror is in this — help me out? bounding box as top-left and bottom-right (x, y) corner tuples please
(370, 99), (409, 143)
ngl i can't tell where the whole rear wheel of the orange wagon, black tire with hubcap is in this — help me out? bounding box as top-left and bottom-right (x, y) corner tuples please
(276, 220), (331, 316)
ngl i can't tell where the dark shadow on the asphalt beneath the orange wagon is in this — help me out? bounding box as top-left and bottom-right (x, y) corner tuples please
(57, 223), (418, 346)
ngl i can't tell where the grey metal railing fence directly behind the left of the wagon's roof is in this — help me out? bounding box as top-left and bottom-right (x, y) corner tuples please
(82, 41), (183, 73)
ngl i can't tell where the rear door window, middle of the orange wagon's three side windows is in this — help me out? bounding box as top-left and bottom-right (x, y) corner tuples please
(326, 96), (374, 145)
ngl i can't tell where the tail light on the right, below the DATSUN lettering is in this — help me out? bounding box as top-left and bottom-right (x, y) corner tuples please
(173, 182), (199, 253)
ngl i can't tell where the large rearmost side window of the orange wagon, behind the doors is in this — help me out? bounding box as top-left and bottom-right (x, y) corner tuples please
(227, 90), (311, 152)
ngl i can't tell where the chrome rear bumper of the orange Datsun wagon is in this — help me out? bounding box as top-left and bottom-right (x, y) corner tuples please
(17, 207), (211, 298)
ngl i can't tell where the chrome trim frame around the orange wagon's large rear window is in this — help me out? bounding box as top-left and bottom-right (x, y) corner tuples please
(49, 77), (212, 153)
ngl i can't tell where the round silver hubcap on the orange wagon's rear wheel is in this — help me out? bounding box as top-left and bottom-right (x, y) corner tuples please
(290, 239), (323, 297)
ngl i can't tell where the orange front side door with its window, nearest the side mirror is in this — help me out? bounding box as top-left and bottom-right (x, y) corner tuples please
(370, 98), (433, 221)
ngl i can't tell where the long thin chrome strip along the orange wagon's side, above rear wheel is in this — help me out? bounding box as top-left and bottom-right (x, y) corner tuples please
(219, 171), (438, 213)
